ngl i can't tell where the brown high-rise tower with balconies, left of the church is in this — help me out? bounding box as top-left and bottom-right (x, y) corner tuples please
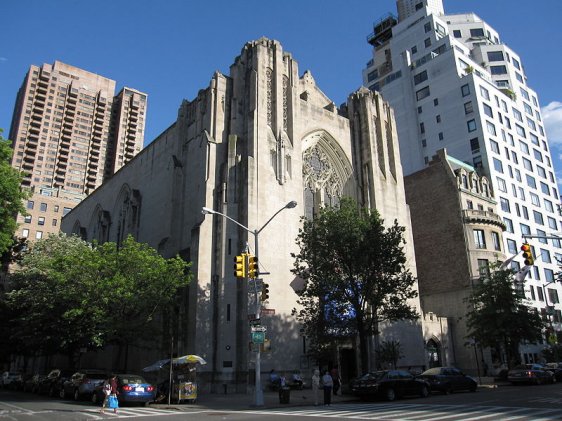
(9, 61), (146, 240)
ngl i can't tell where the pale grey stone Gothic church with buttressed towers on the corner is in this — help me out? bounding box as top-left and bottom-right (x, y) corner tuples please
(62, 38), (438, 391)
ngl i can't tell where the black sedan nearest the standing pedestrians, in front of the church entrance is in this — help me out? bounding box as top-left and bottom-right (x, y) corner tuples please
(351, 370), (430, 401)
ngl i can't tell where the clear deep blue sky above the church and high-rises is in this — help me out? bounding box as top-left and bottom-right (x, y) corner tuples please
(0, 0), (562, 179)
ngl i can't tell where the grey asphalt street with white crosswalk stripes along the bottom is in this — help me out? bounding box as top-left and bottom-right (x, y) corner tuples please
(0, 383), (562, 421)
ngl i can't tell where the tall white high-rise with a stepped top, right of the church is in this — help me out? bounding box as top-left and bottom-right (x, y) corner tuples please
(363, 0), (562, 361)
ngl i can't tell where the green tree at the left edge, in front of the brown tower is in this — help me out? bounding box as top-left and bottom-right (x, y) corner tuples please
(0, 129), (29, 254)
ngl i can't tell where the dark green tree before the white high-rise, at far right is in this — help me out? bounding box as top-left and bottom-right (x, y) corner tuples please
(467, 265), (546, 368)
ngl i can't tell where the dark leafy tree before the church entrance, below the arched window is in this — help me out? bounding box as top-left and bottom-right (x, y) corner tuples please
(292, 199), (418, 370)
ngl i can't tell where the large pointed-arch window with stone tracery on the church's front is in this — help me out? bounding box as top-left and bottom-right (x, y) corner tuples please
(302, 130), (353, 218)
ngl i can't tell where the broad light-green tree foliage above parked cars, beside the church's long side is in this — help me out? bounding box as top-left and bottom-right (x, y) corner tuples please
(6, 234), (191, 366)
